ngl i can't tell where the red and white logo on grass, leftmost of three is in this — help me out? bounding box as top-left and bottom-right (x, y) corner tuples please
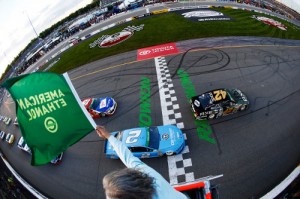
(89, 24), (144, 48)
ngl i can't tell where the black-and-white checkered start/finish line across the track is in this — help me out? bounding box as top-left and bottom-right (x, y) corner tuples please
(154, 57), (195, 185)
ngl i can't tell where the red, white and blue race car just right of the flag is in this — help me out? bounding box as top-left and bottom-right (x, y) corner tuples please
(82, 97), (117, 118)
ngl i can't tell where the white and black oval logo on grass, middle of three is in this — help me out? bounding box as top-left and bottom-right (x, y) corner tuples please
(177, 9), (232, 22)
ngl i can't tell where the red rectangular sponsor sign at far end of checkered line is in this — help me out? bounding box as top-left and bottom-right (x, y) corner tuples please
(137, 43), (179, 61)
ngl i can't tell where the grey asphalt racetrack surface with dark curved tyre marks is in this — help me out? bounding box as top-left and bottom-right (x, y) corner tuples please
(0, 2), (300, 198)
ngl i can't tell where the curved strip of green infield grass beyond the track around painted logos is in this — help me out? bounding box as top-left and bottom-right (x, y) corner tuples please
(47, 8), (300, 73)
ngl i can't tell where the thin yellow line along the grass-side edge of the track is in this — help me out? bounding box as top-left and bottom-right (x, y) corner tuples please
(71, 45), (300, 80)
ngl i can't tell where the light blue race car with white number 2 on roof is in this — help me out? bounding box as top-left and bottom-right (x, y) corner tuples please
(104, 125), (185, 159)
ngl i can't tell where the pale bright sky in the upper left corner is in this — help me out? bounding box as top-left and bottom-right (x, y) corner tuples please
(0, 0), (92, 76)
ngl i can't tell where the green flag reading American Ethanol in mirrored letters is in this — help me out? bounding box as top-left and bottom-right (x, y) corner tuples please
(2, 72), (96, 165)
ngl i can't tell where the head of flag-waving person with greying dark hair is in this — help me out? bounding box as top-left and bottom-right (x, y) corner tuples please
(103, 168), (155, 199)
